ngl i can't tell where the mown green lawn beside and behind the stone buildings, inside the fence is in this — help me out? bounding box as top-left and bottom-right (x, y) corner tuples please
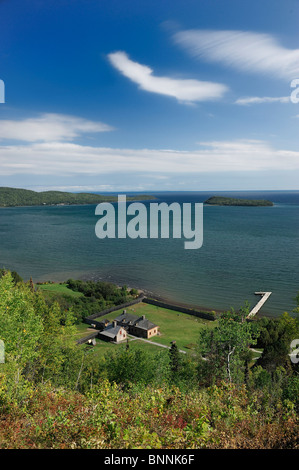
(91, 302), (217, 351)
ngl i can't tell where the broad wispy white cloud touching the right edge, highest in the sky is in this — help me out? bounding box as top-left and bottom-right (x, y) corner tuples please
(173, 30), (299, 80)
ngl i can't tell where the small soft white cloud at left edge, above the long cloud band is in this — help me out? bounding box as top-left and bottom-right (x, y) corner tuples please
(0, 113), (112, 142)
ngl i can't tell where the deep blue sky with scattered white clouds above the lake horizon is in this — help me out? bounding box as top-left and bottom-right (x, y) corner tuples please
(0, 0), (299, 191)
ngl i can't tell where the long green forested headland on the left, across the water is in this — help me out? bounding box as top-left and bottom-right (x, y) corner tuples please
(0, 187), (154, 207)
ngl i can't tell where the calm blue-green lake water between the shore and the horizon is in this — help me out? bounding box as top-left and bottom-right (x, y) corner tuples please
(0, 191), (299, 315)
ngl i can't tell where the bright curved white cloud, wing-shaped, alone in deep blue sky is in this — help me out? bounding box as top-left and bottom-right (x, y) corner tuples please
(108, 51), (227, 103)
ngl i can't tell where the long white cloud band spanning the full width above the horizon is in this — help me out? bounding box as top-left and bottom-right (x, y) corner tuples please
(0, 140), (299, 177)
